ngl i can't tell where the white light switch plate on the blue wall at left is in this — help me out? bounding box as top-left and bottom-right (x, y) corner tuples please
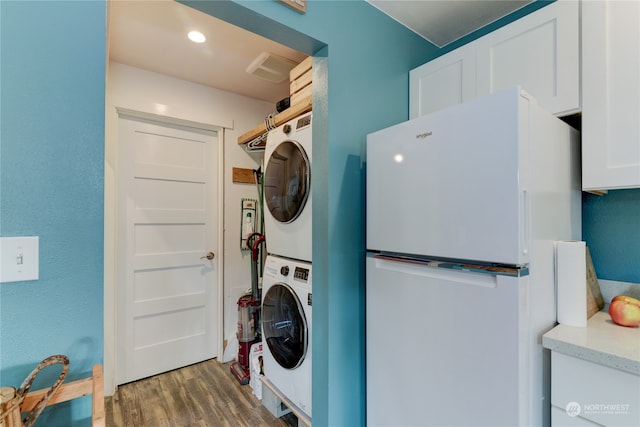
(0, 236), (40, 283)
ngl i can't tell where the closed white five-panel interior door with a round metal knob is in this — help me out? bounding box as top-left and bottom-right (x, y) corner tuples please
(116, 117), (222, 384)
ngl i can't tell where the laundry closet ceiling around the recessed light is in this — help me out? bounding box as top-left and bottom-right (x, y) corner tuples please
(109, 0), (306, 103)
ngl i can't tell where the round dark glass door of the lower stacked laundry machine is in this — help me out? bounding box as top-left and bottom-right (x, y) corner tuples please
(262, 283), (309, 369)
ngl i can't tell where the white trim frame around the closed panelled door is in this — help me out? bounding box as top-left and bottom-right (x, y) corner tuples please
(104, 107), (225, 395)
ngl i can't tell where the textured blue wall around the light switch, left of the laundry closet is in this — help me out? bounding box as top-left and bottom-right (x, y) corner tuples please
(0, 1), (106, 427)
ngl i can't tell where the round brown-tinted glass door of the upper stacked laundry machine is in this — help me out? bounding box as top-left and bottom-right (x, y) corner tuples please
(264, 141), (311, 223)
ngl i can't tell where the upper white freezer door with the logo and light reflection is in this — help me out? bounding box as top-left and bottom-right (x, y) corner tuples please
(367, 88), (529, 265)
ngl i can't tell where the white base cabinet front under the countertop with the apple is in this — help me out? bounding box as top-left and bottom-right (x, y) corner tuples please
(551, 351), (640, 427)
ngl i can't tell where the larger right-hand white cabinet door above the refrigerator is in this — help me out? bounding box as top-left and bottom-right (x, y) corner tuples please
(476, 0), (580, 115)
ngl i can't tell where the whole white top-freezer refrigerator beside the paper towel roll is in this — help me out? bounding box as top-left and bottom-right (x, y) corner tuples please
(366, 87), (581, 427)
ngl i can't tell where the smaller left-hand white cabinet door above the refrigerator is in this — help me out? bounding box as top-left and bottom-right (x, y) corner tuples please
(409, 43), (476, 119)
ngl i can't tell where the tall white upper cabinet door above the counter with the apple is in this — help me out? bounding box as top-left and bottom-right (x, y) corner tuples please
(582, 1), (640, 190)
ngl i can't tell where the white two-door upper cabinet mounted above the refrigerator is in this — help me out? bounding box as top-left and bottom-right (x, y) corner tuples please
(409, 0), (580, 118)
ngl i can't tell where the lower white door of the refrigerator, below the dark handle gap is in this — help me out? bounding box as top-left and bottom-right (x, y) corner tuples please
(366, 257), (536, 427)
